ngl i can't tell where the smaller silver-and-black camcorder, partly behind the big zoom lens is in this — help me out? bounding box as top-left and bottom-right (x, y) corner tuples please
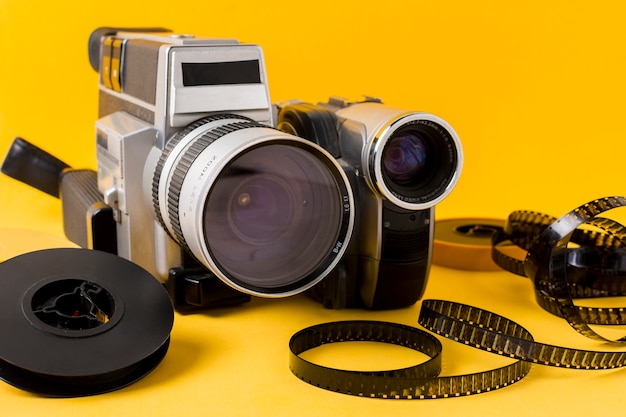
(278, 98), (463, 309)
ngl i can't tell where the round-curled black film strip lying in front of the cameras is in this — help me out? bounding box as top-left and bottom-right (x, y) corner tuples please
(289, 321), (530, 400)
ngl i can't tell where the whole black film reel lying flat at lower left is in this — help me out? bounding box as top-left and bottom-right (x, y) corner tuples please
(0, 248), (174, 397)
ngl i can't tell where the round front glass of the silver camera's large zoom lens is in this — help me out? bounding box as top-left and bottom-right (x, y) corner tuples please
(204, 141), (343, 294)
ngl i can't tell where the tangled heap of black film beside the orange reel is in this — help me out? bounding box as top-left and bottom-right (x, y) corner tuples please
(492, 197), (626, 342)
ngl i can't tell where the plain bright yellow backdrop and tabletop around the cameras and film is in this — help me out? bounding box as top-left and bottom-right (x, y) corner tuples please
(0, 0), (626, 417)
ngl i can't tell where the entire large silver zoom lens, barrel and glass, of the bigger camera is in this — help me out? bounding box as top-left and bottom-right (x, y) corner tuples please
(153, 116), (354, 297)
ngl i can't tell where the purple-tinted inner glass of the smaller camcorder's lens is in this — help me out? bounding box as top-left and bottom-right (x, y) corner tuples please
(383, 132), (427, 184)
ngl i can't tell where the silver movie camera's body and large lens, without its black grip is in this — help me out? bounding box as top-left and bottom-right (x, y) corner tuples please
(90, 28), (355, 304)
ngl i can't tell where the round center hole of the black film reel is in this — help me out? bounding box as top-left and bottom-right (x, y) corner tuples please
(31, 279), (115, 330)
